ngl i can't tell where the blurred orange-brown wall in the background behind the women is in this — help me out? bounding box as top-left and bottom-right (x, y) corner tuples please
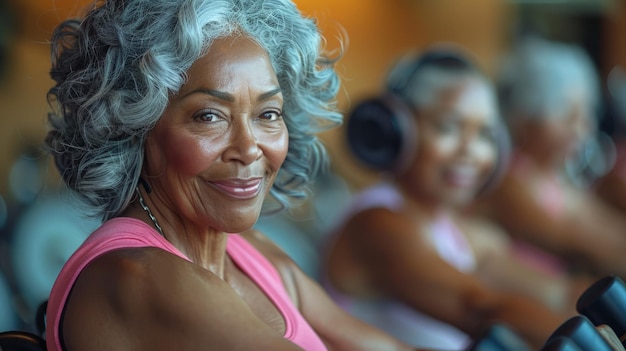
(0, 0), (510, 201)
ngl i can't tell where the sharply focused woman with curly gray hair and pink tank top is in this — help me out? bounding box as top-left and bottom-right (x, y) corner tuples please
(46, 0), (420, 351)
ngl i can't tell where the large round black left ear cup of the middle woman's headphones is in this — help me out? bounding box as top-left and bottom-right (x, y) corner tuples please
(346, 94), (416, 171)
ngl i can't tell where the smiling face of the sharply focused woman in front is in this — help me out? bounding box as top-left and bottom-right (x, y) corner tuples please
(143, 37), (288, 232)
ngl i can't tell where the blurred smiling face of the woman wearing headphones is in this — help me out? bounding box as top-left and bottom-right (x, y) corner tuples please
(400, 76), (498, 205)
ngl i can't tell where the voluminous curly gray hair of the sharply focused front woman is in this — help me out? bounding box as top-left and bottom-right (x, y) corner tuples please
(46, 0), (342, 220)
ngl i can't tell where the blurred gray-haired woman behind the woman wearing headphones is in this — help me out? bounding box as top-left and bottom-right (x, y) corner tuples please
(472, 38), (626, 286)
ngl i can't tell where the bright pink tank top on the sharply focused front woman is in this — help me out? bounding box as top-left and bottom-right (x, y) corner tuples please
(46, 217), (326, 351)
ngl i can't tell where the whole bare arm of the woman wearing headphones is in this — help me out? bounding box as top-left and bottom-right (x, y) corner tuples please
(348, 208), (561, 348)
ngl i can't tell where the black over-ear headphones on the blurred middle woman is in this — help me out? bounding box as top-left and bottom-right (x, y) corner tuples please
(346, 47), (510, 192)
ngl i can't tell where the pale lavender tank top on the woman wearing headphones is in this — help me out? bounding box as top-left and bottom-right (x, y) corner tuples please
(323, 182), (476, 350)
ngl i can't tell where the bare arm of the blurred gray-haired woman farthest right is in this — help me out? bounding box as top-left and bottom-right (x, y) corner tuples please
(489, 177), (626, 276)
